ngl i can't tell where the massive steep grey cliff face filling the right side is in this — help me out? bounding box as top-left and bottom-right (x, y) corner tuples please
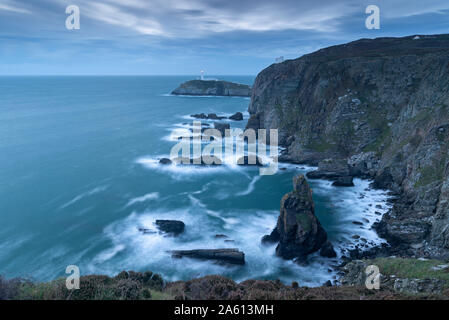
(248, 35), (449, 256)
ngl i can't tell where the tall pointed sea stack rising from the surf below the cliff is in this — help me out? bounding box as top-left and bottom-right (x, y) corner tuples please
(262, 175), (327, 261)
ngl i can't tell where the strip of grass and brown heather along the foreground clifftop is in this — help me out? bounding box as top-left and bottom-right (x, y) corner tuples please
(0, 258), (449, 300)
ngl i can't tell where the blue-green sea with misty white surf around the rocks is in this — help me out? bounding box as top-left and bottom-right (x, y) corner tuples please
(0, 76), (386, 286)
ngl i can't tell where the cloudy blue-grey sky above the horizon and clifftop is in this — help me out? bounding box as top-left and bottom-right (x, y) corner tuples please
(0, 0), (449, 75)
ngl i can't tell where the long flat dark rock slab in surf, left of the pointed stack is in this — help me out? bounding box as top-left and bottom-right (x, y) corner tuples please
(171, 249), (245, 265)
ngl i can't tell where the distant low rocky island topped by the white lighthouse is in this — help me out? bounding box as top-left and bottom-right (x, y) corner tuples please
(172, 80), (251, 97)
